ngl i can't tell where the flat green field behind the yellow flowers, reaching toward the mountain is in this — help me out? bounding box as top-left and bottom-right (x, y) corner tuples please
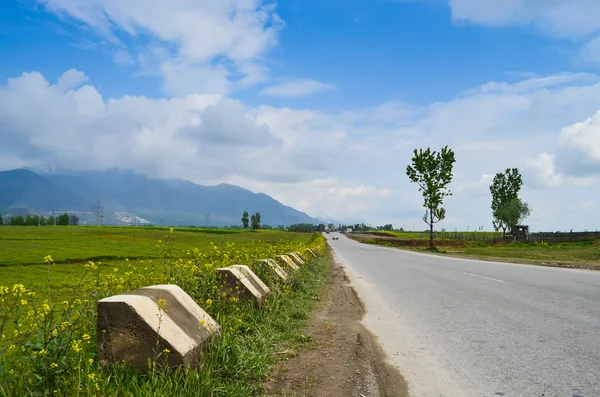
(0, 226), (313, 300)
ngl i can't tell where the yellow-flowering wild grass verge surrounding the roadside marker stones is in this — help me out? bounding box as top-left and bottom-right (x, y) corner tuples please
(0, 230), (329, 397)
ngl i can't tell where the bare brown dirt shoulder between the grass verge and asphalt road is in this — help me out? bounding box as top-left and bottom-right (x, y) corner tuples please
(264, 254), (408, 397)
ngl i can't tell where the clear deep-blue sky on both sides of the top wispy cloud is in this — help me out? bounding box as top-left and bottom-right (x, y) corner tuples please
(0, 0), (585, 106)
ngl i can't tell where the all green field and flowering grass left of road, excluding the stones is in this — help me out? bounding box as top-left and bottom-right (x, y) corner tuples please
(0, 226), (331, 397)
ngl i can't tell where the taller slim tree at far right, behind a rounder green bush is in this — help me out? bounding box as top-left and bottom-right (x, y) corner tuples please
(490, 168), (523, 237)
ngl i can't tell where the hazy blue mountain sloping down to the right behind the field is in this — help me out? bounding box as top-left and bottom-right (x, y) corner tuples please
(0, 170), (320, 226)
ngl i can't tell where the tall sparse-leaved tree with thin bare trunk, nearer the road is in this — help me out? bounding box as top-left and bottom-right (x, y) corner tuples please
(406, 146), (456, 248)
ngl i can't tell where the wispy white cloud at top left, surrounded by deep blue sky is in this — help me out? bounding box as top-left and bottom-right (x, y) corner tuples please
(38, 0), (284, 95)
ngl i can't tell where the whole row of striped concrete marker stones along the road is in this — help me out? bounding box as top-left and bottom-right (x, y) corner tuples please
(97, 248), (318, 371)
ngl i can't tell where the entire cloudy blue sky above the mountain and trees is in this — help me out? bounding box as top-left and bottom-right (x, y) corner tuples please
(0, 0), (600, 229)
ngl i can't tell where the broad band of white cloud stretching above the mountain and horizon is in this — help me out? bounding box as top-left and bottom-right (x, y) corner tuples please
(0, 70), (600, 230)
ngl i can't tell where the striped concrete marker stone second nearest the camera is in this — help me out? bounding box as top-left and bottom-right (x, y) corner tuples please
(217, 265), (271, 306)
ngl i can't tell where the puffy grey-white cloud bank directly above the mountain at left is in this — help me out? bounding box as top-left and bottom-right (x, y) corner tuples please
(0, 71), (290, 179)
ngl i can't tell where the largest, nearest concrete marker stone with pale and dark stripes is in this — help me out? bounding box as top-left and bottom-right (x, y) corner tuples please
(97, 284), (220, 371)
